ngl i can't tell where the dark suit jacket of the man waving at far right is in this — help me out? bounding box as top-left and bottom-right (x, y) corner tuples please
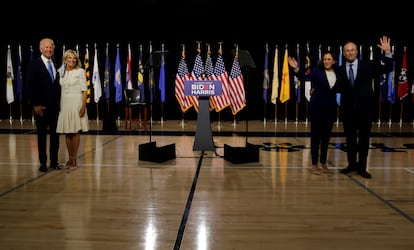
(338, 57), (393, 116)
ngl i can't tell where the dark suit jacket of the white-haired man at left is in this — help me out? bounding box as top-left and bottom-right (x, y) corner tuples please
(25, 57), (61, 111)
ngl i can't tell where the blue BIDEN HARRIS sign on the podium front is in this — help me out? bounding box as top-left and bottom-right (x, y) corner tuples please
(184, 80), (222, 96)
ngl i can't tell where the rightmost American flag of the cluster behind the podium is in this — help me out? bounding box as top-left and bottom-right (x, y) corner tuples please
(229, 52), (246, 115)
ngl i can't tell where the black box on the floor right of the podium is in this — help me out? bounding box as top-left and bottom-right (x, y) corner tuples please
(224, 143), (260, 164)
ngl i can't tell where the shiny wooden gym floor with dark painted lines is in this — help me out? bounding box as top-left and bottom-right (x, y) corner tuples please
(0, 117), (414, 250)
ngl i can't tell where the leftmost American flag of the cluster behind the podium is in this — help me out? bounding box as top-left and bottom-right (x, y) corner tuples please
(175, 50), (193, 112)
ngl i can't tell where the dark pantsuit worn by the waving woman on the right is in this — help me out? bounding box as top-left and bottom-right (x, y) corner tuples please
(298, 65), (338, 165)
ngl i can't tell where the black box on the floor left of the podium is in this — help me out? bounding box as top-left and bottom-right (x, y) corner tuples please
(138, 141), (176, 163)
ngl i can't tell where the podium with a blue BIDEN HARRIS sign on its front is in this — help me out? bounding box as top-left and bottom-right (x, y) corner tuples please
(184, 80), (222, 152)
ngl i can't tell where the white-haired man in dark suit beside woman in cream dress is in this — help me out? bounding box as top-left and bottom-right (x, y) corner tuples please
(25, 38), (62, 172)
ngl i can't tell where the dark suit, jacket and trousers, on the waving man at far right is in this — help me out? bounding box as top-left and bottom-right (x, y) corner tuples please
(338, 57), (393, 171)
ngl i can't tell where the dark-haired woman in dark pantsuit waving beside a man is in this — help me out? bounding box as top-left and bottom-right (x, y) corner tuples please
(288, 51), (338, 175)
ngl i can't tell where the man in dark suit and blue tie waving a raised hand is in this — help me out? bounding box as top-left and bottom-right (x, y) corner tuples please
(338, 36), (393, 179)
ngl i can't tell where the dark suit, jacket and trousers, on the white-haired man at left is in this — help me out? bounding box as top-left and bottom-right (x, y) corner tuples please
(25, 57), (61, 165)
